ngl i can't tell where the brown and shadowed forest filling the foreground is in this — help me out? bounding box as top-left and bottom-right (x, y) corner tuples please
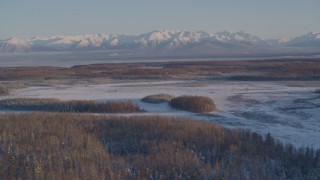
(0, 113), (320, 179)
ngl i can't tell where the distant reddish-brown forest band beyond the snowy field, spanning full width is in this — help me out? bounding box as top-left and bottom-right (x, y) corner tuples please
(0, 58), (320, 81)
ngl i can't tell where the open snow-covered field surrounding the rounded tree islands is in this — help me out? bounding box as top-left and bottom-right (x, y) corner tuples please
(2, 81), (320, 148)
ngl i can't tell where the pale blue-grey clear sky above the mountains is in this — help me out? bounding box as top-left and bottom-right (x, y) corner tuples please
(0, 0), (320, 39)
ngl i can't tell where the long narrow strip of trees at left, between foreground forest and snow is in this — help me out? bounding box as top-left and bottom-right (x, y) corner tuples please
(0, 98), (141, 113)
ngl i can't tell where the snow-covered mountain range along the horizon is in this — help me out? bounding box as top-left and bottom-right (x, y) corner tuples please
(0, 30), (320, 53)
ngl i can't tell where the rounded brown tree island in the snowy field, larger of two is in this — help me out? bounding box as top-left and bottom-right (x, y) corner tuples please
(169, 96), (216, 113)
